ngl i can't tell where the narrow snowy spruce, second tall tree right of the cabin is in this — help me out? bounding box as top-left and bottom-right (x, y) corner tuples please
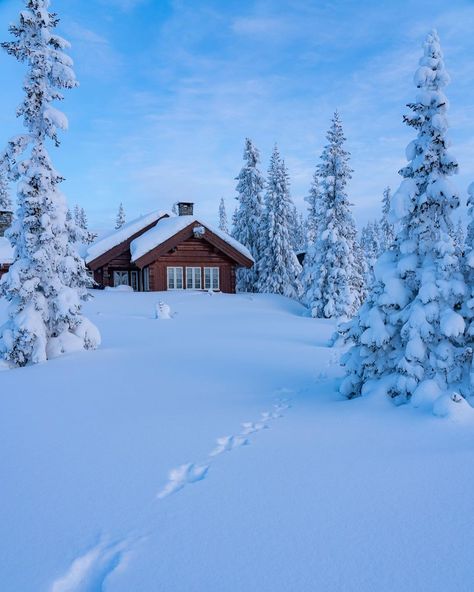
(258, 146), (301, 299)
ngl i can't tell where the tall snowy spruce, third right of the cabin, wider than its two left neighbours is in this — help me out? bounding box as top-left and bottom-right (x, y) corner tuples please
(303, 112), (366, 318)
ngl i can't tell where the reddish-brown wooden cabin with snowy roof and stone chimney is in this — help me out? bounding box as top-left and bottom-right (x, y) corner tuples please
(86, 202), (254, 293)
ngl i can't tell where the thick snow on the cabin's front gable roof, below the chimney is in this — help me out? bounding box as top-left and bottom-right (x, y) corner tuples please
(130, 216), (254, 261)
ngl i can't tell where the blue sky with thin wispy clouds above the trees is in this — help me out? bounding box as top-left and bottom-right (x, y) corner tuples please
(0, 0), (474, 228)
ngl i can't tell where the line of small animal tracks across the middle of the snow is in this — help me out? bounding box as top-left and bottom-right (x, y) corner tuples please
(157, 389), (292, 500)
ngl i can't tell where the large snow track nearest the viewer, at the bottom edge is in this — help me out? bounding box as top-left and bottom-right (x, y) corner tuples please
(51, 540), (130, 592)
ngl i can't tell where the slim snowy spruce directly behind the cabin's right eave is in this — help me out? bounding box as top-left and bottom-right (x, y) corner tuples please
(232, 138), (265, 292)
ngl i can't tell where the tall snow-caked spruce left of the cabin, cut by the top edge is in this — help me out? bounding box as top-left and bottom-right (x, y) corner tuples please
(0, 0), (100, 366)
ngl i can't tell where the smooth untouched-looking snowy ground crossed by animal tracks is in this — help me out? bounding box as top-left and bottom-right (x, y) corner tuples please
(0, 292), (474, 592)
